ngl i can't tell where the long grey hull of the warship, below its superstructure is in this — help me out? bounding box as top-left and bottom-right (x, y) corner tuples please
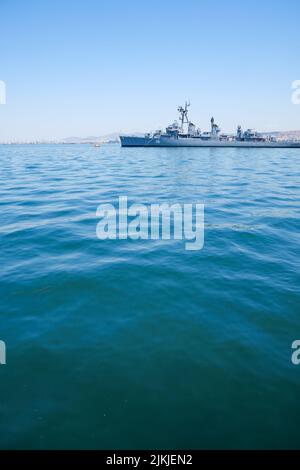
(120, 136), (300, 149)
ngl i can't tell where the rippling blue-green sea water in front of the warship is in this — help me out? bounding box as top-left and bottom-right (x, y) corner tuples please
(0, 144), (300, 449)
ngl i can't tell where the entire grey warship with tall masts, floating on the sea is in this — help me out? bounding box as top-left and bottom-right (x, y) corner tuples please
(120, 102), (300, 148)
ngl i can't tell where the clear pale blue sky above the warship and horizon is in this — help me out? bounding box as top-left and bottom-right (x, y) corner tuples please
(0, 0), (300, 141)
